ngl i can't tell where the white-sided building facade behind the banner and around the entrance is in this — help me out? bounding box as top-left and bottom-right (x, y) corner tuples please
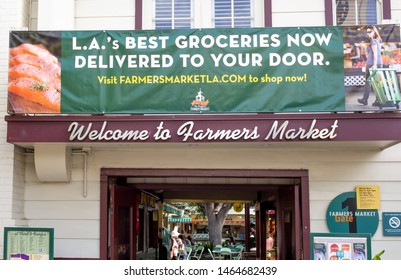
(0, 0), (401, 259)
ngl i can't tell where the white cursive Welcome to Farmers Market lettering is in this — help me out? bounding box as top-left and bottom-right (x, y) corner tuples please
(68, 120), (338, 142)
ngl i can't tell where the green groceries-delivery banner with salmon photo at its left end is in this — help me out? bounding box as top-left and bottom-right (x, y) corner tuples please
(12, 27), (396, 114)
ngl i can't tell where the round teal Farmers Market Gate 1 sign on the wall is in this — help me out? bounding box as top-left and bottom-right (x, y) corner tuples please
(326, 192), (379, 236)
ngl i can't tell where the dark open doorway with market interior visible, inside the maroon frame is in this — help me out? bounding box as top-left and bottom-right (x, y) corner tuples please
(102, 173), (309, 260)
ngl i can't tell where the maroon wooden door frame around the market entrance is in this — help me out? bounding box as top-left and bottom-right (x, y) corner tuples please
(99, 168), (310, 260)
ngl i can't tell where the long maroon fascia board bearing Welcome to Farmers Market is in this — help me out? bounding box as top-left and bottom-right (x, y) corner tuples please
(5, 112), (401, 144)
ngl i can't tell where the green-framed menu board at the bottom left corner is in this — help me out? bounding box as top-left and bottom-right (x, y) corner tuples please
(4, 227), (54, 260)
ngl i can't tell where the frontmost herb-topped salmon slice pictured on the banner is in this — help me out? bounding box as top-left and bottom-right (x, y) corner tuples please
(8, 77), (60, 112)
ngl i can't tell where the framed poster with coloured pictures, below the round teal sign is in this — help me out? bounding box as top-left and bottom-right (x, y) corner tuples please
(310, 233), (372, 260)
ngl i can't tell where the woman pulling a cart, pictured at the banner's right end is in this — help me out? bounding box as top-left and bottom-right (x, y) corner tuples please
(358, 26), (383, 106)
